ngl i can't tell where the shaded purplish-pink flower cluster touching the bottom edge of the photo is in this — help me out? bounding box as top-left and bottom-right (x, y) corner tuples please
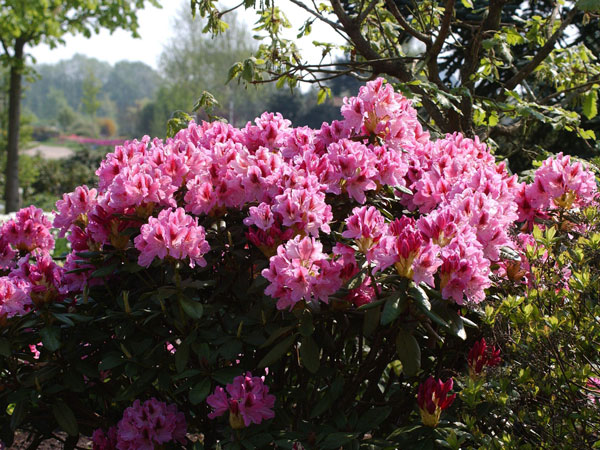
(92, 398), (187, 450)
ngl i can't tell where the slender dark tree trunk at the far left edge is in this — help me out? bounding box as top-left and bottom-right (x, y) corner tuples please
(4, 39), (25, 213)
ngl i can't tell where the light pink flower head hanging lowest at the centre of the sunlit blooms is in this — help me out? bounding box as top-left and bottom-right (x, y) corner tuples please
(262, 236), (341, 309)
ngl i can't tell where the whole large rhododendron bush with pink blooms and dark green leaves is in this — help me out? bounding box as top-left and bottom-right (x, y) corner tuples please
(0, 79), (596, 449)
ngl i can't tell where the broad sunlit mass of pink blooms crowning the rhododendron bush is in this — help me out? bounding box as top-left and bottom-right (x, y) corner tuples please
(24, 74), (596, 309)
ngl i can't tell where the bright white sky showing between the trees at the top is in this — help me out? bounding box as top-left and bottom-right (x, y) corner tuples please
(29, 0), (342, 69)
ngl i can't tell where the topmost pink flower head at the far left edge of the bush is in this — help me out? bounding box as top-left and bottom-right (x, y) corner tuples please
(0, 206), (54, 252)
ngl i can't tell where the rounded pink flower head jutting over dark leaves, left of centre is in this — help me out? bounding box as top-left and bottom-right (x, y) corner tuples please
(134, 208), (210, 267)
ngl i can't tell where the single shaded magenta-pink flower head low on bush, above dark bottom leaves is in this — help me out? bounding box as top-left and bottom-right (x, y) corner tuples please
(206, 372), (275, 429)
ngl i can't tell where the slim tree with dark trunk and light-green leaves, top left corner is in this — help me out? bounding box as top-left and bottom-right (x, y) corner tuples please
(0, 0), (158, 211)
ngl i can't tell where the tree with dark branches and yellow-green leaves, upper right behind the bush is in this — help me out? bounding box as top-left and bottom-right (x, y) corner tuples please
(192, 0), (600, 165)
